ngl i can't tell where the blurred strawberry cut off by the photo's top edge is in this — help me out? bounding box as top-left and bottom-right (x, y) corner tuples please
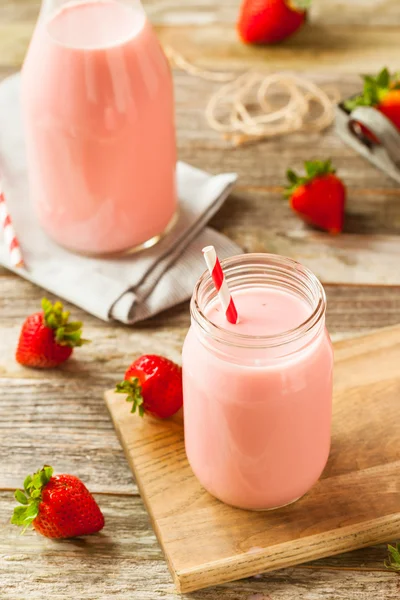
(237, 0), (311, 44)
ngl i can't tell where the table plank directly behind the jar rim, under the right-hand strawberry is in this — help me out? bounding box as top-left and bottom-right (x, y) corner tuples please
(2, 182), (400, 286)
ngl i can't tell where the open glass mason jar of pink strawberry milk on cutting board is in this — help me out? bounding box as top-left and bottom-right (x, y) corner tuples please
(182, 254), (333, 510)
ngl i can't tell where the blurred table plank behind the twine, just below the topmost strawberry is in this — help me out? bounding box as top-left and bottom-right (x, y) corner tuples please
(0, 20), (400, 73)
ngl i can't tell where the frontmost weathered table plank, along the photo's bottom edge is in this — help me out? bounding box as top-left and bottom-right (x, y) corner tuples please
(0, 493), (398, 600)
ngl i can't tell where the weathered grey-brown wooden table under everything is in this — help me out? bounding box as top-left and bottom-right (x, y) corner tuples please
(0, 0), (400, 600)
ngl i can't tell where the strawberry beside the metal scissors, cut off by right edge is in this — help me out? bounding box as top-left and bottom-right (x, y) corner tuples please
(344, 68), (400, 143)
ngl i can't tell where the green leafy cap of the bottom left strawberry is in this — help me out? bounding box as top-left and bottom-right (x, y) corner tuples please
(11, 465), (53, 531)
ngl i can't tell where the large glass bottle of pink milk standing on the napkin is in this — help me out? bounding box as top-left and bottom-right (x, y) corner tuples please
(22, 0), (177, 255)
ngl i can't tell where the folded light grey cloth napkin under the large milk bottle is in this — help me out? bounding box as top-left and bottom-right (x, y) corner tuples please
(0, 75), (241, 323)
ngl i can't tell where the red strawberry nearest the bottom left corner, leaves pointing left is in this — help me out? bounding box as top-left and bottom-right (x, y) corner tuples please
(11, 466), (104, 538)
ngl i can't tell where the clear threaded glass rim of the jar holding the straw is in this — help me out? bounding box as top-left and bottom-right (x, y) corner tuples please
(190, 253), (326, 348)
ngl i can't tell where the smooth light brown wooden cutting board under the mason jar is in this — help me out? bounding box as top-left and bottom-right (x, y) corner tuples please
(105, 326), (400, 592)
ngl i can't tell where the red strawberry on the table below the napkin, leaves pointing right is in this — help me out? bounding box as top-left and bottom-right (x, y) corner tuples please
(15, 298), (88, 369)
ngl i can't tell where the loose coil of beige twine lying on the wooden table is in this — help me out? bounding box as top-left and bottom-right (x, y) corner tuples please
(166, 47), (340, 146)
